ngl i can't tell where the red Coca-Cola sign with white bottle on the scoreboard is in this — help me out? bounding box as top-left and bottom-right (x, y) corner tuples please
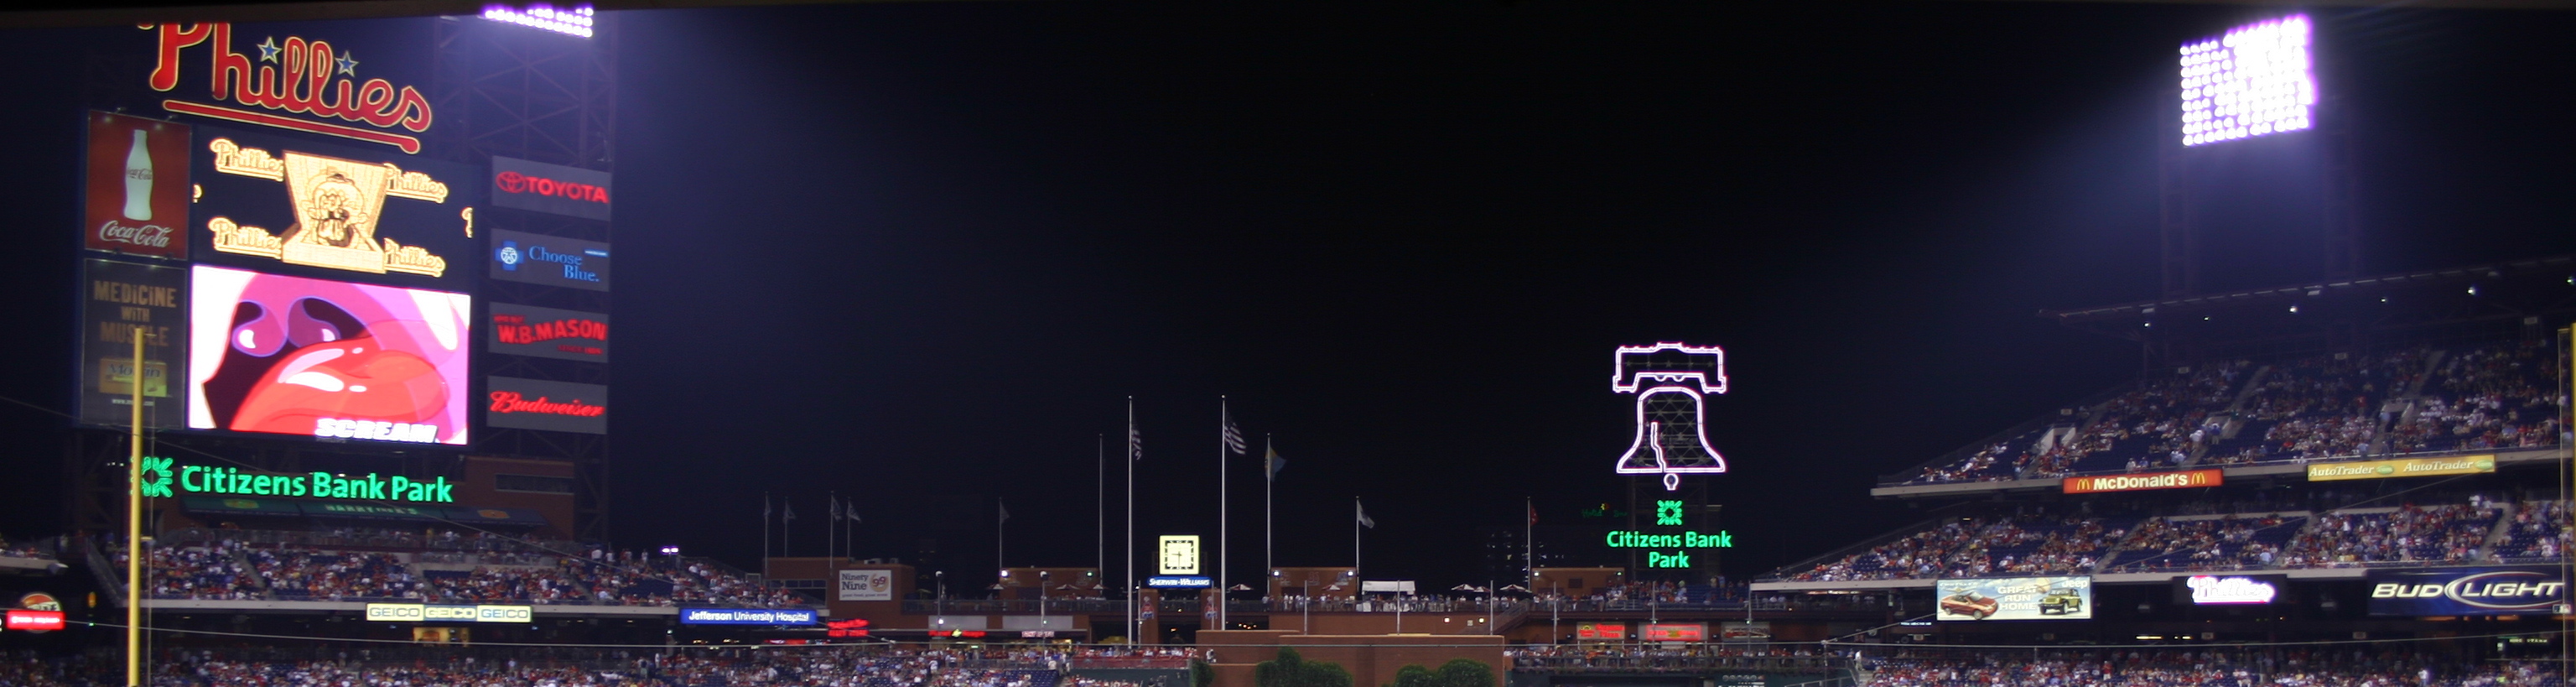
(80, 113), (190, 260)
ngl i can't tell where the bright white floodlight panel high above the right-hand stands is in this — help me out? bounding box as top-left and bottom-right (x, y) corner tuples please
(2182, 15), (2316, 147)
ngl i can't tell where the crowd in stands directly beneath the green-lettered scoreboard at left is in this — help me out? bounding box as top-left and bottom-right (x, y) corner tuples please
(147, 530), (814, 607)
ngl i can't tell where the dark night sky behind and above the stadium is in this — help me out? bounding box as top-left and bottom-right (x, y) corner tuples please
(0, 0), (2576, 589)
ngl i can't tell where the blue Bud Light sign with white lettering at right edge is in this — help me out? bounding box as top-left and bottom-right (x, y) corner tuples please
(2370, 566), (2568, 615)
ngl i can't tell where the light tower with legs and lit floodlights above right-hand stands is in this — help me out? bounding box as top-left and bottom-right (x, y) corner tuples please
(2158, 15), (2362, 299)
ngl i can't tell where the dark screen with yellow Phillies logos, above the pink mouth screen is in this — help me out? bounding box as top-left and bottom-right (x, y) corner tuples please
(193, 126), (481, 289)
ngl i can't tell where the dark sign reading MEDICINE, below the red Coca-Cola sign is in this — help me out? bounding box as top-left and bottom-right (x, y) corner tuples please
(80, 258), (188, 427)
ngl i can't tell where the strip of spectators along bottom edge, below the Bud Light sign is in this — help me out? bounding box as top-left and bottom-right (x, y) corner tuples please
(1862, 648), (2566, 687)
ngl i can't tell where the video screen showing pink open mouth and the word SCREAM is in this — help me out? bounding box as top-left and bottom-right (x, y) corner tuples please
(188, 265), (474, 445)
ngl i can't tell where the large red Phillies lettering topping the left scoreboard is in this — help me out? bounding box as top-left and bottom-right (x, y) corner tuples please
(142, 23), (430, 154)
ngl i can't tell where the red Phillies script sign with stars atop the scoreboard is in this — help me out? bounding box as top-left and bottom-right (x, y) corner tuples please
(139, 23), (433, 154)
